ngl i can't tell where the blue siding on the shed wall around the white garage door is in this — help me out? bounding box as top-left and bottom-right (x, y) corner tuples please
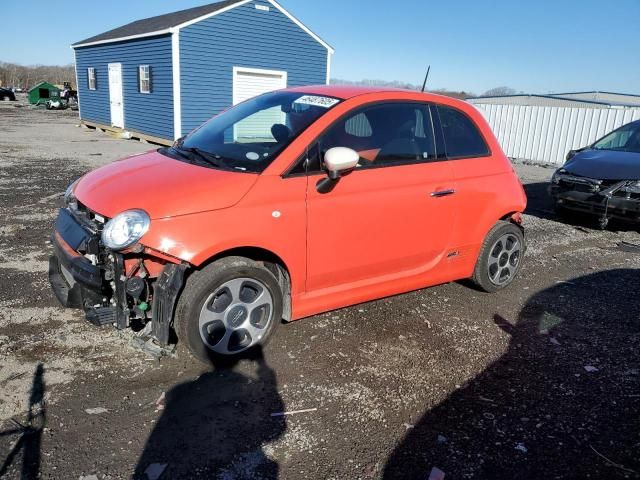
(180, 2), (327, 134)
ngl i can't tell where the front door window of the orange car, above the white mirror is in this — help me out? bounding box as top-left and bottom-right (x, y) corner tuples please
(318, 103), (436, 168)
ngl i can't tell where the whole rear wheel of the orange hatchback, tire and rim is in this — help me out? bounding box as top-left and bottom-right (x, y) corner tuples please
(472, 221), (524, 292)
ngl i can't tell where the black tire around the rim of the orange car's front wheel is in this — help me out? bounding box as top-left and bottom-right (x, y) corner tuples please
(175, 257), (283, 364)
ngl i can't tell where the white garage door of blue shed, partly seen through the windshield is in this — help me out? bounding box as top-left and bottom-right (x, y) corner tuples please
(233, 67), (287, 142)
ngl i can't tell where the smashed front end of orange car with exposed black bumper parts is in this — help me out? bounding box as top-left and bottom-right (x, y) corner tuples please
(49, 208), (188, 346)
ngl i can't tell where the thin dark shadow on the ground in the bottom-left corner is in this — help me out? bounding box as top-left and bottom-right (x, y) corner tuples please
(0, 364), (47, 480)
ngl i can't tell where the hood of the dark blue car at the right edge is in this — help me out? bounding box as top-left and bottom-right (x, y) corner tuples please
(564, 149), (640, 180)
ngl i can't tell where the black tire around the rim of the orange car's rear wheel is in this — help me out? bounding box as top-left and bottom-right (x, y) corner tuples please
(471, 220), (525, 293)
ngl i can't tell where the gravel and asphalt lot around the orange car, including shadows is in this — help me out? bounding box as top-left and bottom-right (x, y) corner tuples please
(0, 102), (640, 480)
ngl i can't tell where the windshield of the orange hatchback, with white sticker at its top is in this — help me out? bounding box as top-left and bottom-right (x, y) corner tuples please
(164, 91), (340, 173)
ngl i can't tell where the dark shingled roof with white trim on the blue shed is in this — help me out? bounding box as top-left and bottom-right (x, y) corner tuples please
(71, 0), (333, 53)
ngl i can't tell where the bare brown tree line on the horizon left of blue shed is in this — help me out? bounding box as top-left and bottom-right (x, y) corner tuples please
(0, 62), (76, 89)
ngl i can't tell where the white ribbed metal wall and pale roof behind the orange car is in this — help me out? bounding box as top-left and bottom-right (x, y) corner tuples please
(469, 92), (640, 165)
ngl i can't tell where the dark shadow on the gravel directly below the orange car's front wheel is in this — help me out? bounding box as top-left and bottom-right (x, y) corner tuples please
(134, 351), (286, 479)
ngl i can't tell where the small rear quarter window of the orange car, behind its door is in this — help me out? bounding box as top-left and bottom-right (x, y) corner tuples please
(438, 105), (489, 158)
